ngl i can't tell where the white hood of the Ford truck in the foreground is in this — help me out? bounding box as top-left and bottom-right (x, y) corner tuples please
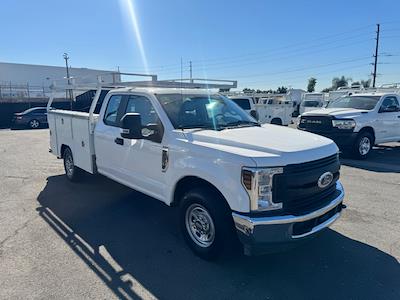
(186, 124), (338, 166)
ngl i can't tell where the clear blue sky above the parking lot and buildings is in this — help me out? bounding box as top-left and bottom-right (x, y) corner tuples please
(0, 0), (400, 90)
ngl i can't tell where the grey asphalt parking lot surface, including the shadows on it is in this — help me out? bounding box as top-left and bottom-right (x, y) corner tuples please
(0, 129), (400, 299)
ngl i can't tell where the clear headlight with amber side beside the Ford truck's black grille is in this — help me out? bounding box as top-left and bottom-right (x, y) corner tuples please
(242, 167), (283, 211)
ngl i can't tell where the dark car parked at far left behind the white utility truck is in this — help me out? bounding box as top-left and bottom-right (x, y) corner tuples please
(11, 107), (48, 129)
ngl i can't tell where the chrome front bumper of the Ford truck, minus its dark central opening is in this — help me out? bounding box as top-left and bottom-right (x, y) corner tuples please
(232, 181), (344, 252)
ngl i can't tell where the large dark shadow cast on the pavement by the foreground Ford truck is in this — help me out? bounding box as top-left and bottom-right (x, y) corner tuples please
(38, 175), (400, 299)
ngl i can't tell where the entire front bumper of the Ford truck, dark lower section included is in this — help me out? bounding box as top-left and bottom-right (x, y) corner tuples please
(232, 181), (344, 254)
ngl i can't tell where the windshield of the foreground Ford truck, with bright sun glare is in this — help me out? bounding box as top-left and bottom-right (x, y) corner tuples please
(156, 94), (259, 130)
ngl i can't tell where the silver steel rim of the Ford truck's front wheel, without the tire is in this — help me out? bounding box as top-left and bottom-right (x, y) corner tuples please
(185, 203), (215, 248)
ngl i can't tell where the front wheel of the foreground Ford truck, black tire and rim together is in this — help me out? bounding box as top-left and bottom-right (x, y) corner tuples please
(179, 187), (238, 260)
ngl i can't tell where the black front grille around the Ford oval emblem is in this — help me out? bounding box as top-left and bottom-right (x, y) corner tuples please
(273, 154), (340, 215)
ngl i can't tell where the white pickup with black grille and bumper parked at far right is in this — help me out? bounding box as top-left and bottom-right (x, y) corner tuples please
(298, 92), (400, 159)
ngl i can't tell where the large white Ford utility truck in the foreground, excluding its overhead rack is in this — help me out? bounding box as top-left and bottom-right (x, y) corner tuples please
(48, 79), (344, 259)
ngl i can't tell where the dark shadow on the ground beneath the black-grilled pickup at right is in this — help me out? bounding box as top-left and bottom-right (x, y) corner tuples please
(340, 143), (400, 173)
